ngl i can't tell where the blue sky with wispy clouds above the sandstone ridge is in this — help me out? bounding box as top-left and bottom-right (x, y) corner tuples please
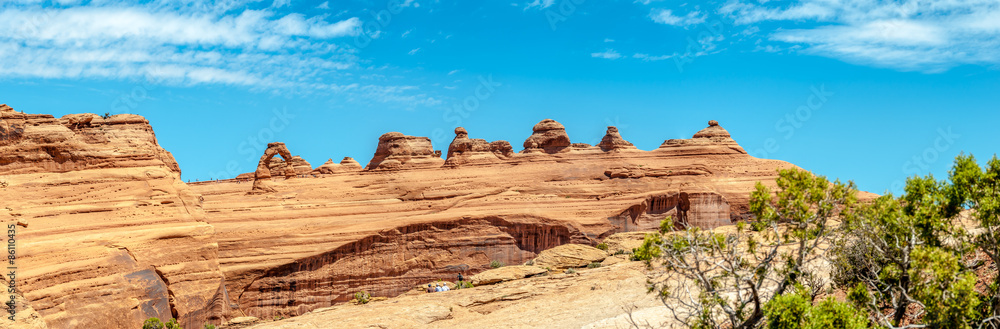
(0, 0), (1000, 193)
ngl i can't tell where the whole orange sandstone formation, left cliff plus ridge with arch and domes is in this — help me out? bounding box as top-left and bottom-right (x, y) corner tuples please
(7, 102), (852, 328)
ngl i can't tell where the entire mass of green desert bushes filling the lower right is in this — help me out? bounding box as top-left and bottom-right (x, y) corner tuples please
(632, 155), (1000, 328)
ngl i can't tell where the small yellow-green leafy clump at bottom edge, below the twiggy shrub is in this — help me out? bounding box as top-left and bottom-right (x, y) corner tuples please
(764, 286), (868, 329)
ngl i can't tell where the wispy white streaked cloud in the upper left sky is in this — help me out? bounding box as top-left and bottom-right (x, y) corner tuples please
(0, 0), (442, 105)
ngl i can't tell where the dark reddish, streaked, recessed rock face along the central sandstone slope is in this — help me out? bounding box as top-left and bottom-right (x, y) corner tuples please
(237, 217), (594, 318)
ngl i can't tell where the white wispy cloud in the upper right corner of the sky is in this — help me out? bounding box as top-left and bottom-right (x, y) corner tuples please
(719, 0), (1000, 72)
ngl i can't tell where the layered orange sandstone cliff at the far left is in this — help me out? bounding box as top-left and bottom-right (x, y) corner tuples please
(0, 106), (229, 328)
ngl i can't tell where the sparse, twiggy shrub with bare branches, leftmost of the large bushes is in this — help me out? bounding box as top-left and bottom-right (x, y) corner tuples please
(633, 169), (857, 328)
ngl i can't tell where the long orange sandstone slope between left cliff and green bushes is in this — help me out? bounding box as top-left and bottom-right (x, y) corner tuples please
(192, 121), (794, 318)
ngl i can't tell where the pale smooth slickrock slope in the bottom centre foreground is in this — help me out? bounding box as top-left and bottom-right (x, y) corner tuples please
(238, 262), (677, 329)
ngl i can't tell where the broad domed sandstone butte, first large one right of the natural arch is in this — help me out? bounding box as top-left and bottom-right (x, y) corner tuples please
(366, 132), (444, 170)
